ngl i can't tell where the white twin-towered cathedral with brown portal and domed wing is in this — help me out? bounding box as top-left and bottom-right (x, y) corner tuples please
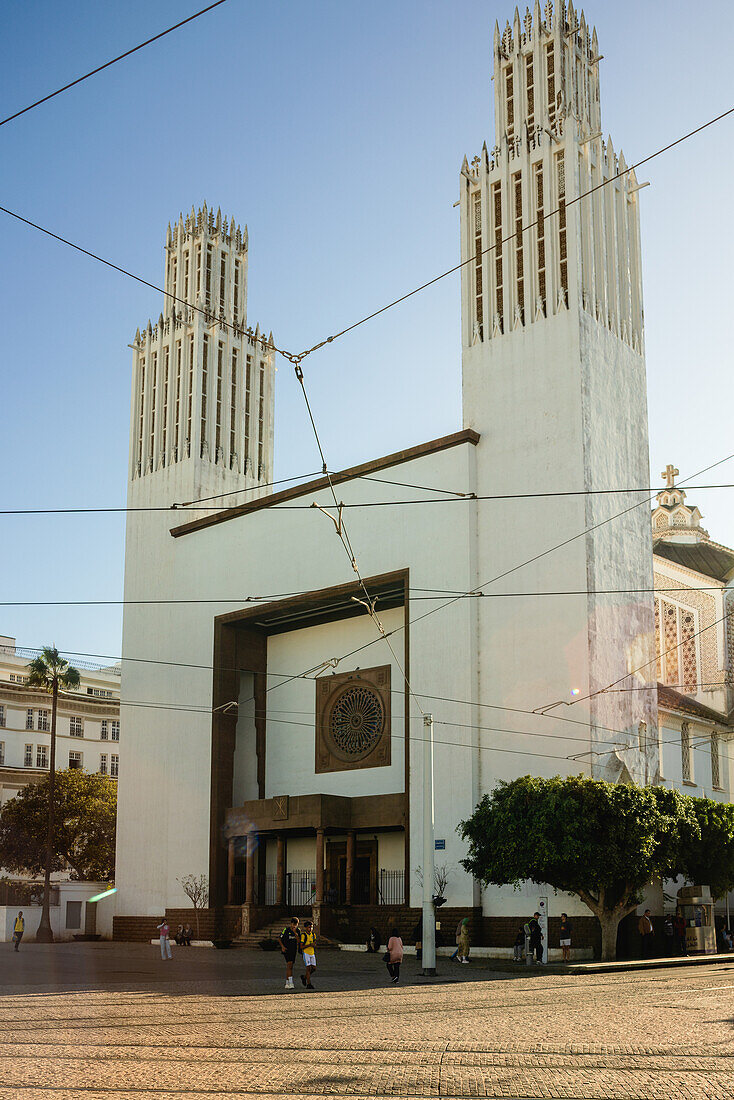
(116, 2), (734, 945)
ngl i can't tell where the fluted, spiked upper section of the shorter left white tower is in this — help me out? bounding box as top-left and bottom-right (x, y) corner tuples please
(130, 204), (274, 498)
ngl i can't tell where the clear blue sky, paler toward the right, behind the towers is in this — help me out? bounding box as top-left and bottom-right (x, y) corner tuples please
(0, 0), (734, 657)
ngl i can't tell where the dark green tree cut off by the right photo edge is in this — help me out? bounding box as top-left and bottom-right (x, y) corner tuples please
(680, 799), (734, 898)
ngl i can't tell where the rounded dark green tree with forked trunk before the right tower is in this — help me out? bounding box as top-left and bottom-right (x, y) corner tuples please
(459, 776), (700, 959)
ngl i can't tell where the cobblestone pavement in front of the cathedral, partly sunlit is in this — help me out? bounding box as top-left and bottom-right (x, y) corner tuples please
(0, 944), (734, 1100)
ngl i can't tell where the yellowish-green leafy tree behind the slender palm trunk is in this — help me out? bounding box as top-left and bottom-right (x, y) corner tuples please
(0, 768), (117, 882)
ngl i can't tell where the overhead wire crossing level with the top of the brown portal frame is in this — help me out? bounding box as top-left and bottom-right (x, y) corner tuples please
(0, 584), (722, 611)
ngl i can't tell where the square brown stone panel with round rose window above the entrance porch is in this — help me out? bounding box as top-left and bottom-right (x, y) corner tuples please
(316, 664), (391, 774)
